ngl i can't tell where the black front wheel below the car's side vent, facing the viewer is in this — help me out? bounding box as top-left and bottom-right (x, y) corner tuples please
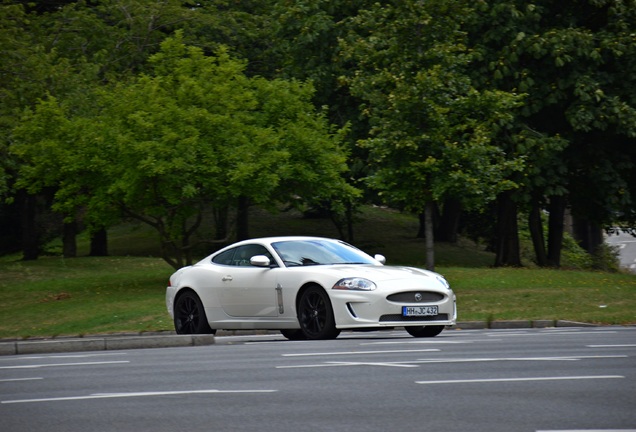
(298, 286), (340, 340)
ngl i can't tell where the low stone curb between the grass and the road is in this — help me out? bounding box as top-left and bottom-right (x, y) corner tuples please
(0, 320), (598, 356)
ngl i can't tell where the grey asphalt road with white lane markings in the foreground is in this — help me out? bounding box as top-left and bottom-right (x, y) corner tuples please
(0, 327), (636, 432)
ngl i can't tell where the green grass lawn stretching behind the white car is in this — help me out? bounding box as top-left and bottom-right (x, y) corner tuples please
(0, 204), (636, 338)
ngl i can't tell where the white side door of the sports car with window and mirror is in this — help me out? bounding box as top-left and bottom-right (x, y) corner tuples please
(219, 244), (278, 317)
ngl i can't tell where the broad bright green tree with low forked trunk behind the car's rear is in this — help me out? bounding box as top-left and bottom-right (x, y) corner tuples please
(14, 35), (356, 268)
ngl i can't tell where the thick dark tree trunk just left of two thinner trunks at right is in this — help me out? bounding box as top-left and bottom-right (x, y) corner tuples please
(495, 192), (521, 267)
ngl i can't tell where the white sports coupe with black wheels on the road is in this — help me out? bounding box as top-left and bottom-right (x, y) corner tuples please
(166, 237), (457, 339)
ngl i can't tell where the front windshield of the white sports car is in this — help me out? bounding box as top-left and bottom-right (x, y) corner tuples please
(272, 239), (377, 267)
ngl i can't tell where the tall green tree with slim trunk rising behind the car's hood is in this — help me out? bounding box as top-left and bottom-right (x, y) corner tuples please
(342, 1), (522, 268)
